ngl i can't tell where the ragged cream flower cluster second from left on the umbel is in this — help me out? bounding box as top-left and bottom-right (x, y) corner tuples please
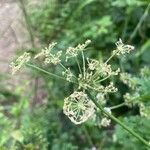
(34, 43), (62, 65)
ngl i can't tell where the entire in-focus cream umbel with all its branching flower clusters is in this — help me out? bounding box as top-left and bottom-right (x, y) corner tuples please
(12, 39), (134, 124)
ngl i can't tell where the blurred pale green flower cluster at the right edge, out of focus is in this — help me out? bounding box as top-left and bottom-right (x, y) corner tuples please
(121, 67), (150, 118)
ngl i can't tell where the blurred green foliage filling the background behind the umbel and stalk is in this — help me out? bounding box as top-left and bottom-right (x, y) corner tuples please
(0, 0), (150, 150)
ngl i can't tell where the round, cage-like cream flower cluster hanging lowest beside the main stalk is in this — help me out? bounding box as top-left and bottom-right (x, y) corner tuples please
(63, 91), (95, 124)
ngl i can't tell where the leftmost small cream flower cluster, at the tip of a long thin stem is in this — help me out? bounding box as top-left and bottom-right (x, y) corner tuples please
(10, 52), (31, 74)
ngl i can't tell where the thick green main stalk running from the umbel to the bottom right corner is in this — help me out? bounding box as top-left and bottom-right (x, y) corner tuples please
(87, 91), (150, 148)
